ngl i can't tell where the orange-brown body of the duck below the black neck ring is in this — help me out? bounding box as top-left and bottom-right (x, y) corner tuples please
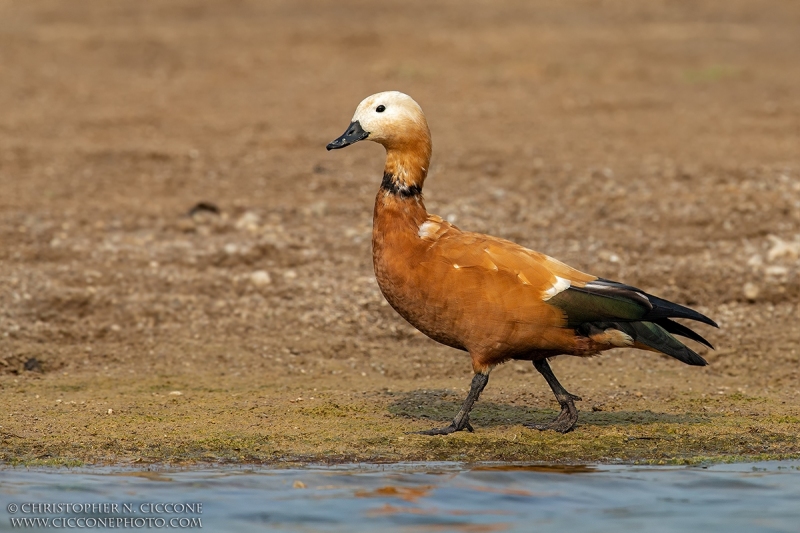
(372, 191), (613, 372)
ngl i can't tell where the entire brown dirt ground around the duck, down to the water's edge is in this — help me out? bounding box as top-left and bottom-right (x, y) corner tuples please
(0, 0), (800, 464)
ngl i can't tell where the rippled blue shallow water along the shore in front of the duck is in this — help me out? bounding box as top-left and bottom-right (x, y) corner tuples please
(0, 461), (800, 533)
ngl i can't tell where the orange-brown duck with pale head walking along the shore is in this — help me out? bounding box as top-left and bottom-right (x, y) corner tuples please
(327, 91), (718, 435)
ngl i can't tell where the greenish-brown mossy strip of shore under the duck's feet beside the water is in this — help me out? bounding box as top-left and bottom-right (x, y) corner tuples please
(0, 368), (800, 469)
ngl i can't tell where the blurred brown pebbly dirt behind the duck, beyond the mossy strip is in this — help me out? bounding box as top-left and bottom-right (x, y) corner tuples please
(0, 0), (800, 412)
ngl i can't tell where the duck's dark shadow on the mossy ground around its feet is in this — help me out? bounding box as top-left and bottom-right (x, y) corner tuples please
(388, 390), (709, 427)
